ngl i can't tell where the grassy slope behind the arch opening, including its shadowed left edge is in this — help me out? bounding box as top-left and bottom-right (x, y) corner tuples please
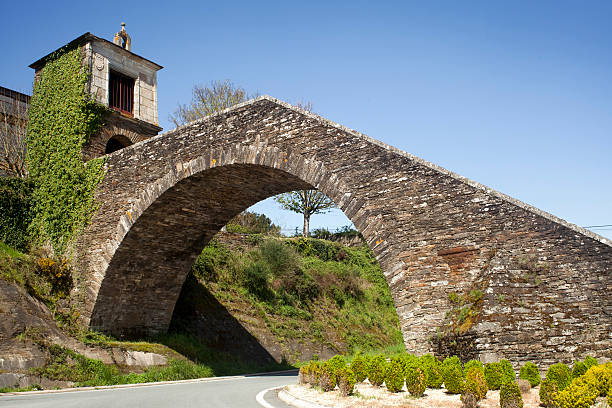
(172, 236), (402, 362)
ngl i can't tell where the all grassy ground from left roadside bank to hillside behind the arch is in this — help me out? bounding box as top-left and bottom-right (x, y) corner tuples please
(0, 233), (401, 392)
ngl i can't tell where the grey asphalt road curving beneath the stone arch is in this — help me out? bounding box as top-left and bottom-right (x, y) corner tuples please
(0, 371), (297, 408)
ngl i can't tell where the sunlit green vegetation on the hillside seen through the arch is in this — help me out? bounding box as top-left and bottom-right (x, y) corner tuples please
(193, 236), (402, 357)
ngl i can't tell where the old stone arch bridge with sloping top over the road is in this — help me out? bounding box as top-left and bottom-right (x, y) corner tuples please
(76, 96), (612, 361)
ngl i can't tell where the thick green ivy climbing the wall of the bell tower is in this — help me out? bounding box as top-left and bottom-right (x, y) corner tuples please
(27, 47), (106, 255)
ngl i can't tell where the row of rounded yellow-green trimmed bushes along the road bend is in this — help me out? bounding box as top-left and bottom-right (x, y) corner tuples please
(298, 353), (612, 408)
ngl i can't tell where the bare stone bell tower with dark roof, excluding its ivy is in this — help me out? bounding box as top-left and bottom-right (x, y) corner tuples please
(30, 23), (163, 160)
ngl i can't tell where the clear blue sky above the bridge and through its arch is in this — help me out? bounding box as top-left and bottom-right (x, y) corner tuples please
(0, 0), (612, 237)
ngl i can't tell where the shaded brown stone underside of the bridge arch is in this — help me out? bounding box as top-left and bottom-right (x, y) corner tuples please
(90, 164), (313, 337)
